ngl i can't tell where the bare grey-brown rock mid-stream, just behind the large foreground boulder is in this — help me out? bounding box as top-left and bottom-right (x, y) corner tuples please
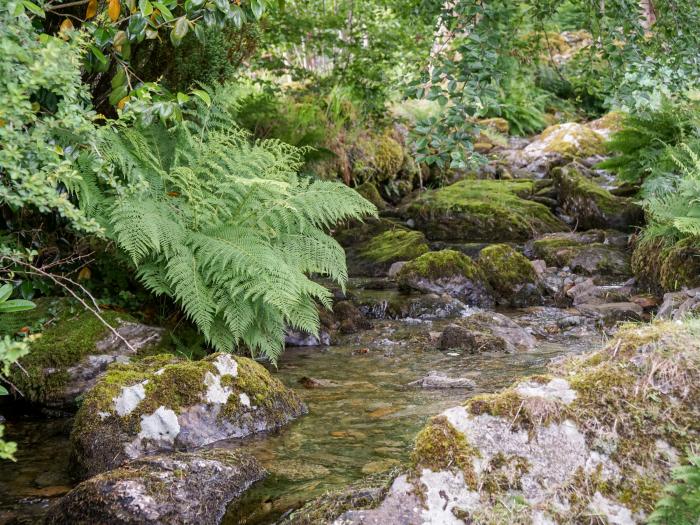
(437, 312), (535, 354)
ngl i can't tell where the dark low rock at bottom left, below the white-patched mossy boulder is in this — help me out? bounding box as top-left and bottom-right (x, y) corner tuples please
(46, 449), (265, 525)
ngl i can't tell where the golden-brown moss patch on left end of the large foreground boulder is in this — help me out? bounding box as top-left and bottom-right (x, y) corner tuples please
(411, 416), (480, 489)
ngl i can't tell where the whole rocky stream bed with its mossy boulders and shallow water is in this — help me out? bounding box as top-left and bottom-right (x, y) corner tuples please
(0, 118), (700, 524)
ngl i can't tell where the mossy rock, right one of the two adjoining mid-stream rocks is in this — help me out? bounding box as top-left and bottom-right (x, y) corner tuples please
(478, 244), (537, 297)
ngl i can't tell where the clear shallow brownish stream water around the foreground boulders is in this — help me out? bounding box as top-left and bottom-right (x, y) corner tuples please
(0, 320), (595, 525)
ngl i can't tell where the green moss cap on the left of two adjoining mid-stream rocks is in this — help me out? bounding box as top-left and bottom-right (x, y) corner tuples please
(396, 250), (485, 286)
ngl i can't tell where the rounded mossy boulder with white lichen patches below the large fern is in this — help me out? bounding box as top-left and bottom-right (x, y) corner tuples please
(71, 353), (306, 477)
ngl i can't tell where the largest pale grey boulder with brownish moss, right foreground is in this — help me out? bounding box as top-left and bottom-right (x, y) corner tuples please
(335, 322), (700, 525)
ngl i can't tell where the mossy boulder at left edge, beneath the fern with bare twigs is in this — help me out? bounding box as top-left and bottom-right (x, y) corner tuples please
(2, 298), (164, 410)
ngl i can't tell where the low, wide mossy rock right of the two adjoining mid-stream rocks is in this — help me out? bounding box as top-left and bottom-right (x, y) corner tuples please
(526, 230), (631, 277)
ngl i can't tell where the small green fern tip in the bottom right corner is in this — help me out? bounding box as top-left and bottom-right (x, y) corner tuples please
(649, 456), (700, 525)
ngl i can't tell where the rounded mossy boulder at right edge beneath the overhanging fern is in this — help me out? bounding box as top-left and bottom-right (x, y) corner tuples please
(632, 237), (700, 292)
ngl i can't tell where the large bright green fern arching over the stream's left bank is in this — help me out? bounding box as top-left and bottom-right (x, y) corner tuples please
(91, 87), (376, 361)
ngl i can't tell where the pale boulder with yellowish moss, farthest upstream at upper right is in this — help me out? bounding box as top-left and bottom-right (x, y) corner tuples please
(523, 122), (606, 159)
